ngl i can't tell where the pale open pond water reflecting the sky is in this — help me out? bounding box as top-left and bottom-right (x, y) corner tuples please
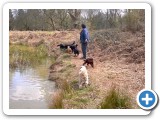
(9, 62), (55, 109)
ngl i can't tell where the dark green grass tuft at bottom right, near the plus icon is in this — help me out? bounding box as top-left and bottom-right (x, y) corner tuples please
(100, 88), (131, 109)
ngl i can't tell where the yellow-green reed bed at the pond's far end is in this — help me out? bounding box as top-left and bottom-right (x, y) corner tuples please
(9, 45), (51, 68)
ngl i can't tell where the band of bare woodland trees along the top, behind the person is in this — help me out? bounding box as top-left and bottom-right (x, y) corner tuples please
(9, 9), (145, 31)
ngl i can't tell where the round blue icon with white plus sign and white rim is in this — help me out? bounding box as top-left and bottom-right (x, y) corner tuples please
(137, 90), (157, 110)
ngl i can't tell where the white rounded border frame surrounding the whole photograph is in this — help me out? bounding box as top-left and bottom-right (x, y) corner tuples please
(3, 3), (151, 115)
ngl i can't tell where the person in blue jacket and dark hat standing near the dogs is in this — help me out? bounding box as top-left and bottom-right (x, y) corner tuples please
(80, 24), (89, 59)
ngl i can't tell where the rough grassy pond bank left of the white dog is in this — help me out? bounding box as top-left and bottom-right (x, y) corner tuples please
(48, 48), (96, 109)
